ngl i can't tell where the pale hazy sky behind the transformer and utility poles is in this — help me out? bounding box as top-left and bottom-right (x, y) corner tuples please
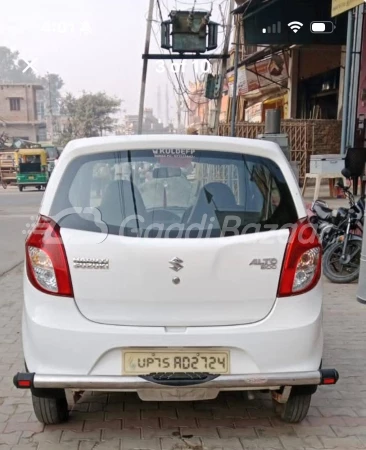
(0, 0), (228, 125)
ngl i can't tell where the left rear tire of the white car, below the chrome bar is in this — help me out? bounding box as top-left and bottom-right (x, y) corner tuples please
(32, 390), (69, 425)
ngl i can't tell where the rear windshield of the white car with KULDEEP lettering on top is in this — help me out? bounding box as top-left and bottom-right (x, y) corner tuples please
(50, 148), (298, 238)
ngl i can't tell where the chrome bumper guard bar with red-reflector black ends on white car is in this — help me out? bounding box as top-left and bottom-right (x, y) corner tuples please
(13, 369), (339, 391)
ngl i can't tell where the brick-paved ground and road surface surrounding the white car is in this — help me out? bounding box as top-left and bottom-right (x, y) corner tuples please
(0, 188), (366, 450)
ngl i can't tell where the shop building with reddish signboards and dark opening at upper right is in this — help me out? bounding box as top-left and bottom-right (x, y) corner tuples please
(223, 6), (345, 123)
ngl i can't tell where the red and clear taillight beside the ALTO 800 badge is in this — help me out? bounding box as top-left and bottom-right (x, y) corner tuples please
(278, 219), (321, 297)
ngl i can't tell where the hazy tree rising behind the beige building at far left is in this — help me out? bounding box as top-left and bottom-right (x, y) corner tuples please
(0, 47), (64, 112)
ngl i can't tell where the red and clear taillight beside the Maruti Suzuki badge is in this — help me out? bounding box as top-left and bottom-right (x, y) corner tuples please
(25, 216), (73, 297)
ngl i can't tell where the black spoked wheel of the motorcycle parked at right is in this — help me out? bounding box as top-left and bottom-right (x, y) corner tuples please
(323, 240), (362, 284)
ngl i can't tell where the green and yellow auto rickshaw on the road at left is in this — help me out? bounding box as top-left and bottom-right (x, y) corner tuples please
(15, 148), (49, 191)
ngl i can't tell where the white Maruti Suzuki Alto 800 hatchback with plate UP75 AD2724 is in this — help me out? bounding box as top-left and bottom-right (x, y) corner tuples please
(14, 135), (338, 424)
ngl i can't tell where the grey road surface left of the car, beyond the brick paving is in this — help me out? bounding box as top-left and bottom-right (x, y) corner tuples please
(0, 187), (43, 276)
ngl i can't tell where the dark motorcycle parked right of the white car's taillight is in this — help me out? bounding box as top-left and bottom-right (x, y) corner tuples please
(312, 169), (365, 283)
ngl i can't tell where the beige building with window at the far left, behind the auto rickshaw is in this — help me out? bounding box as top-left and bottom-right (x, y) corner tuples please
(0, 83), (46, 142)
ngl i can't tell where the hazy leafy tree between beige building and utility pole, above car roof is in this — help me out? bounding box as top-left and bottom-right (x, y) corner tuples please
(60, 91), (121, 145)
